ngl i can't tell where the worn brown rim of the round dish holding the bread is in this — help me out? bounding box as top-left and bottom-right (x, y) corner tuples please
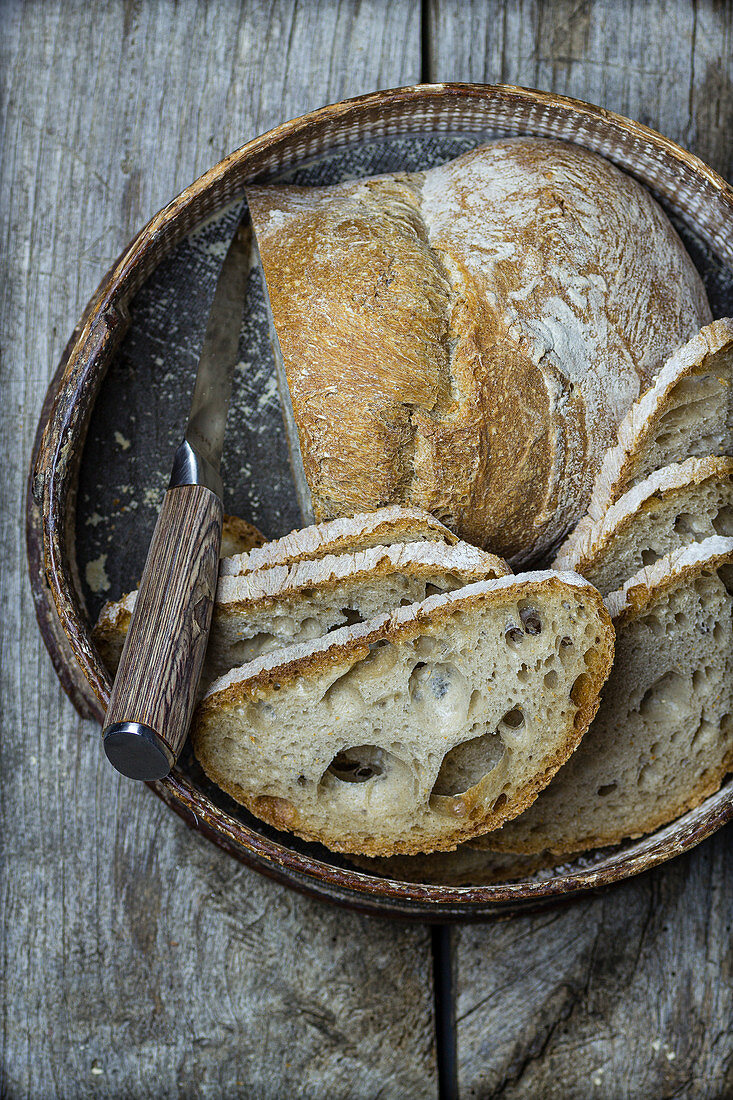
(26, 83), (733, 921)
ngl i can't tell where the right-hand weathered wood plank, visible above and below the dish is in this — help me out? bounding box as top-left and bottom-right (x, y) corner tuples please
(428, 0), (733, 1100)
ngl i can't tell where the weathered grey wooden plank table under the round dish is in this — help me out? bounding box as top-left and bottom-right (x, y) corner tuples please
(0, 0), (733, 1100)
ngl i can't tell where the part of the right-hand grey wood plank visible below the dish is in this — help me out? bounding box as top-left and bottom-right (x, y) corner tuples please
(455, 831), (733, 1100)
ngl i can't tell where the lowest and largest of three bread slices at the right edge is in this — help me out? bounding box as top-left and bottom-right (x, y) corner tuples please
(483, 537), (733, 853)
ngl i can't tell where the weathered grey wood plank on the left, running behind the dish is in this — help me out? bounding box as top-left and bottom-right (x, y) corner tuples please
(0, 0), (436, 1097)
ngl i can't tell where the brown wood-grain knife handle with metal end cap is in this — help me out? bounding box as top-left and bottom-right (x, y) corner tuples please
(103, 485), (223, 780)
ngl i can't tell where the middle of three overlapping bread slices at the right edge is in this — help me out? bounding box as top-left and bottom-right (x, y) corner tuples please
(553, 458), (733, 595)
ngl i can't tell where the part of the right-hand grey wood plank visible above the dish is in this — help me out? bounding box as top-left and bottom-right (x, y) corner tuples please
(427, 0), (733, 178)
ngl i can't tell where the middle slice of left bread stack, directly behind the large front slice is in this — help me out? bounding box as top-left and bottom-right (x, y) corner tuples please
(94, 542), (511, 690)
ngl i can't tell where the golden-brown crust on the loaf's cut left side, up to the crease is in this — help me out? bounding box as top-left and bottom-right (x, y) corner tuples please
(248, 179), (450, 519)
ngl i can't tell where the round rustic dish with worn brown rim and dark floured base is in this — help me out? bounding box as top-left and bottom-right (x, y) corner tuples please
(28, 84), (733, 921)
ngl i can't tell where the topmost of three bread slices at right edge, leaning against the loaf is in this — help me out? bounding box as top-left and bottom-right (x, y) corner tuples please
(588, 317), (733, 520)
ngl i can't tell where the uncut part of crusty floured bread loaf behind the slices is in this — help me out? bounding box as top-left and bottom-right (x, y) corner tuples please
(248, 139), (710, 561)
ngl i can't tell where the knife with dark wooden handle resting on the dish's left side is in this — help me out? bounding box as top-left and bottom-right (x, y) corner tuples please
(102, 212), (249, 780)
